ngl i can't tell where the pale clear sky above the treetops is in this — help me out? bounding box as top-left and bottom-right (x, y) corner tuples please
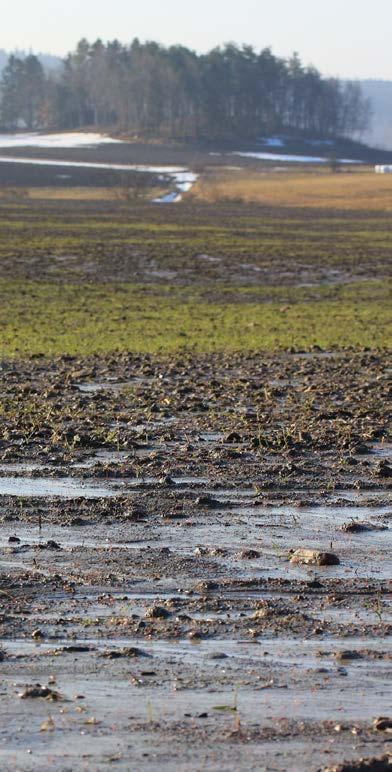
(0, 0), (392, 80)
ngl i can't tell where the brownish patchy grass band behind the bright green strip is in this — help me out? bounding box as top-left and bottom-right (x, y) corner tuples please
(0, 198), (392, 286)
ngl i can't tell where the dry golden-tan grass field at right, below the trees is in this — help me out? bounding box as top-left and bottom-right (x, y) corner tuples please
(192, 169), (392, 212)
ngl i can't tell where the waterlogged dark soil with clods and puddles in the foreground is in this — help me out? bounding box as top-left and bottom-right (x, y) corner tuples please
(0, 351), (392, 771)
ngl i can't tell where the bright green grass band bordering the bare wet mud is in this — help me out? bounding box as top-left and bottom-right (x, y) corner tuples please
(0, 280), (391, 357)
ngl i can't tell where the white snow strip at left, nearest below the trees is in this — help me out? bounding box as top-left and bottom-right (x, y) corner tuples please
(0, 131), (121, 148)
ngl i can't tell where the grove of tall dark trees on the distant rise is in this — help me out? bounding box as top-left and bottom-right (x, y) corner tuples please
(0, 39), (370, 139)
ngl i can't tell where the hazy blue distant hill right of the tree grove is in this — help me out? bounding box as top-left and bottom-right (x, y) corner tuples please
(360, 80), (392, 150)
